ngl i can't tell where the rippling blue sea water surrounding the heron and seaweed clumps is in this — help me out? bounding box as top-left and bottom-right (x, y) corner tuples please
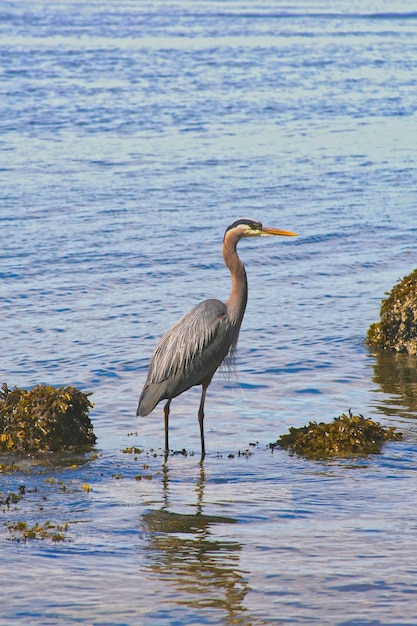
(0, 0), (417, 626)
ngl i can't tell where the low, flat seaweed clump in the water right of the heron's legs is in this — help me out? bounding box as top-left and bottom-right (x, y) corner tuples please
(269, 410), (402, 459)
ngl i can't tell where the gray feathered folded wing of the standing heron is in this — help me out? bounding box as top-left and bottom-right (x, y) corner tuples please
(138, 299), (234, 415)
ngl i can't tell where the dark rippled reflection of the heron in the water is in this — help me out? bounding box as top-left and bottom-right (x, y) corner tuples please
(142, 463), (252, 625)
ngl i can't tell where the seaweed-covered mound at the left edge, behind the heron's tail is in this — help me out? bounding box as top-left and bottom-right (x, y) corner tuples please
(0, 384), (96, 455)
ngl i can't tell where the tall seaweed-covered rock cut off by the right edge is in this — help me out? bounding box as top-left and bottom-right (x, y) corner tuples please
(366, 269), (417, 355)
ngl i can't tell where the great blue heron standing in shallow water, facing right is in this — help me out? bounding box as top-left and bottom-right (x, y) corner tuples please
(137, 218), (296, 459)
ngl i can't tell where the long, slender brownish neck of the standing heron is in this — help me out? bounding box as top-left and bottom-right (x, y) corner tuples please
(223, 233), (248, 326)
